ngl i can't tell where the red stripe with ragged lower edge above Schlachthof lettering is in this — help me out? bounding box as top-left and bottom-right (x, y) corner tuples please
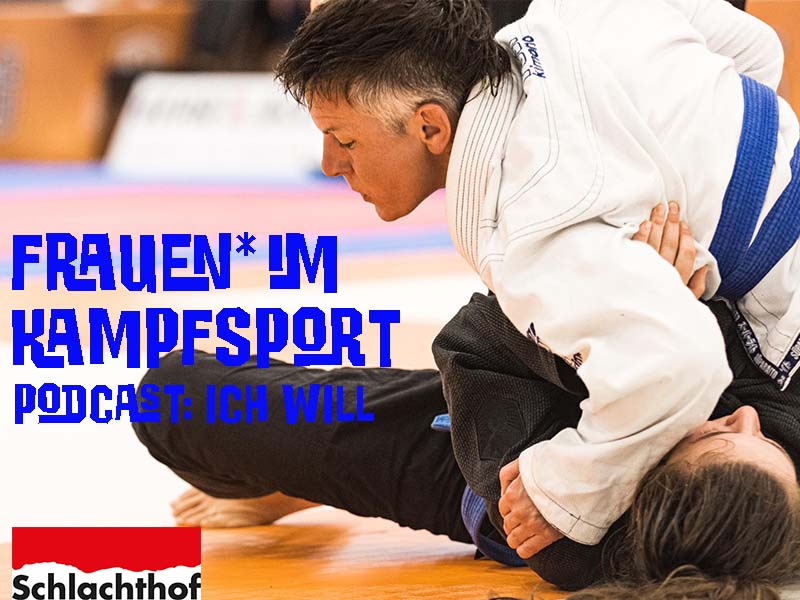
(11, 527), (200, 573)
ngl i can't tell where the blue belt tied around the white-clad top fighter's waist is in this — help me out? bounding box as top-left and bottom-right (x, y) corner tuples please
(709, 75), (800, 301)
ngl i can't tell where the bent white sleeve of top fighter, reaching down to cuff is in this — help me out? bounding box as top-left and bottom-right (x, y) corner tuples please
(494, 222), (731, 544)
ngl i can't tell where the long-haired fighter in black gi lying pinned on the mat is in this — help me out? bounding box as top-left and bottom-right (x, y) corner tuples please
(134, 216), (800, 599)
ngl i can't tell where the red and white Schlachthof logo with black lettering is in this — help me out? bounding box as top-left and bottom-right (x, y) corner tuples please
(11, 527), (200, 600)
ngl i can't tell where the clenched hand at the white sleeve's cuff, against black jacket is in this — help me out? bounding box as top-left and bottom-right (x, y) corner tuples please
(498, 459), (564, 559)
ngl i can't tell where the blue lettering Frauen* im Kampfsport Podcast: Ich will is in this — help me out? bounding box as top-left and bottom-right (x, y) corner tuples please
(11, 232), (400, 423)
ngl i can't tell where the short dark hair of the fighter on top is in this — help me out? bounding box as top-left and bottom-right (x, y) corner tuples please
(277, 0), (511, 130)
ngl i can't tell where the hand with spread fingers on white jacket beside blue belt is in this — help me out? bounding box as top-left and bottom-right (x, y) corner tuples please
(633, 202), (708, 298)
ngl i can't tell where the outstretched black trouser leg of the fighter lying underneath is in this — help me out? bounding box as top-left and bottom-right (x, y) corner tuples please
(129, 352), (470, 542)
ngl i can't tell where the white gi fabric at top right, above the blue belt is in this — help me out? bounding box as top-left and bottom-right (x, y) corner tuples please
(665, 0), (783, 90)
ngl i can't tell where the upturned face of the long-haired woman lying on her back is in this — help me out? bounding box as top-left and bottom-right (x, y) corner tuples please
(667, 406), (798, 492)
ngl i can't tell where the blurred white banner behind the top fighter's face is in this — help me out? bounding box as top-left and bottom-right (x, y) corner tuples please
(106, 73), (322, 181)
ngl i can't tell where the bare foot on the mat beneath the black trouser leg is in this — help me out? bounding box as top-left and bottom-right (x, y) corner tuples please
(170, 488), (318, 528)
